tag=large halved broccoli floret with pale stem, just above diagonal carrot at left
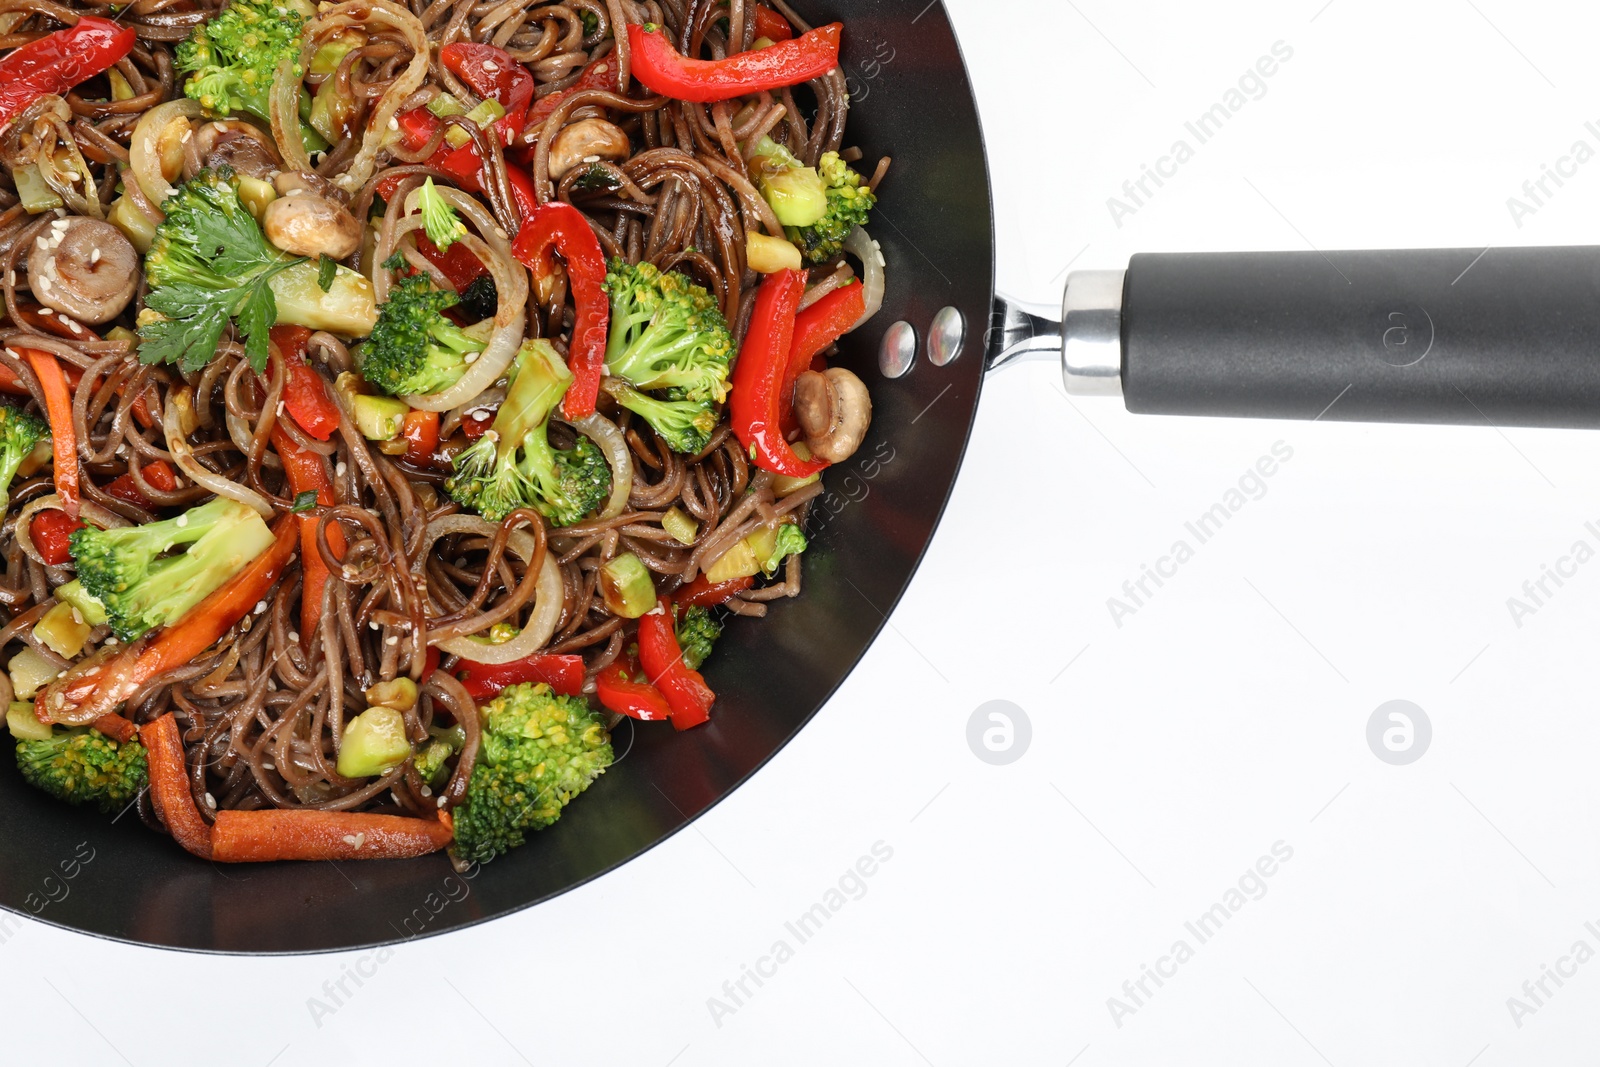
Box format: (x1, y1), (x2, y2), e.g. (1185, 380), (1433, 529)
(70, 498), (272, 641)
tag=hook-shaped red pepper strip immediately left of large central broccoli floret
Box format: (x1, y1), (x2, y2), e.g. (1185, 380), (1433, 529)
(510, 200), (611, 422)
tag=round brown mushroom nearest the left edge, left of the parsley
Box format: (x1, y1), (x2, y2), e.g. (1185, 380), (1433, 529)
(27, 218), (139, 325)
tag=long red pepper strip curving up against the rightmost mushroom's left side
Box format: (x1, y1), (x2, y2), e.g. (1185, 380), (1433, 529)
(728, 270), (827, 478)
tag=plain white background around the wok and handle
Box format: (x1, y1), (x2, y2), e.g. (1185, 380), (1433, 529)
(9, 0), (1600, 1067)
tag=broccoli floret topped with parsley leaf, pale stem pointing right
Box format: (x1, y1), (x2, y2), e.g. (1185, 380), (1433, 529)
(139, 166), (378, 373)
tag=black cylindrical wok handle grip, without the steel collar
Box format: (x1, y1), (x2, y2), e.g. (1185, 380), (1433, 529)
(1122, 248), (1600, 427)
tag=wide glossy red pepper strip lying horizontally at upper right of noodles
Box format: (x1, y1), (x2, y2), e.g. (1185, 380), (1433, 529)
(627, 22), (845, 104)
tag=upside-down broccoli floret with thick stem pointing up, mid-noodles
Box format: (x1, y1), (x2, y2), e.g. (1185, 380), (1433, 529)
(445, 339), (611, 526)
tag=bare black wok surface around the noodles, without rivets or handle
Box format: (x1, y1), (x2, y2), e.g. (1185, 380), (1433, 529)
(0, 0), (994, 953)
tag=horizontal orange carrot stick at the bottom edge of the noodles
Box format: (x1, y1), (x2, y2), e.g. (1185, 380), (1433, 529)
(211, 809), (451, 864)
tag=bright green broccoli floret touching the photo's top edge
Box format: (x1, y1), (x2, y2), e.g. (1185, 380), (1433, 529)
(174, 0), (328, 152)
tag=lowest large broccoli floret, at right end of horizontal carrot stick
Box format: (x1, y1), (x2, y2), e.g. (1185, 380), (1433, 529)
(454, 683), (613, 864)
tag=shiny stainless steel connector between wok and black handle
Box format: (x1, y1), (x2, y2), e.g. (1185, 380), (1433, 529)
(986, 270), (1126, 397)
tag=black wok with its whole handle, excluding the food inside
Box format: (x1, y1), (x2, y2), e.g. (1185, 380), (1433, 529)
(0, 0), (1574, 953)
